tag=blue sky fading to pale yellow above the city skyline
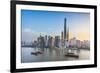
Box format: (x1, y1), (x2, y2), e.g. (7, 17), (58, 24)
(21, 10), (90, 40)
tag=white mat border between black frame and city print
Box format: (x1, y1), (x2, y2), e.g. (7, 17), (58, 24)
(16, 4), (94, 69)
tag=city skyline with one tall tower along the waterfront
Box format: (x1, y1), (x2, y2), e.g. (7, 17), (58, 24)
(21, 18), (90, 49)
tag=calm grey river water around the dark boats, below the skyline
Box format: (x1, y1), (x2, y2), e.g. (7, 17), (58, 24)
(21, 47), (90, 63)
